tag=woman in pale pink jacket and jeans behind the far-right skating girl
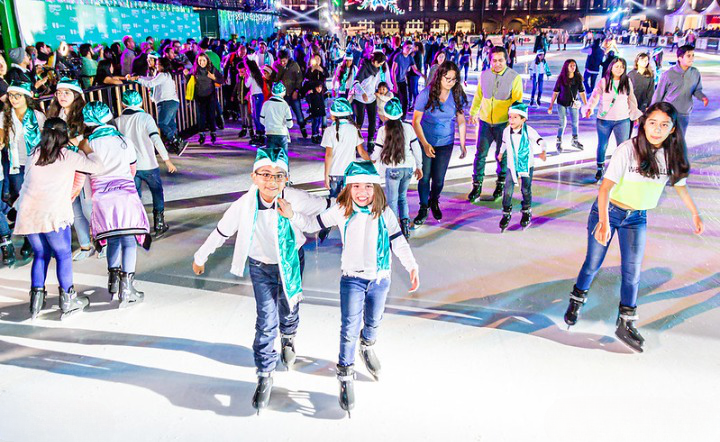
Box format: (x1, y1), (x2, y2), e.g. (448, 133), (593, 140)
(585, 58), (642, 181)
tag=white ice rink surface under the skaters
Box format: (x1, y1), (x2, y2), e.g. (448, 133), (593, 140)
(0, 46), (720, 442)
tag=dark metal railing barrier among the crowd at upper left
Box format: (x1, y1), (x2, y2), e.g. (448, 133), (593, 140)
(38, 74), (223, 136)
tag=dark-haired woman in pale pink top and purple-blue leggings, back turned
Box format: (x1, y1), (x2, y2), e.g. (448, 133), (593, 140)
(15, 118), (102, 319)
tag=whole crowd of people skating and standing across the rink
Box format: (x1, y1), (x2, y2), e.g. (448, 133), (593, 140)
(0, 26), (708, 411)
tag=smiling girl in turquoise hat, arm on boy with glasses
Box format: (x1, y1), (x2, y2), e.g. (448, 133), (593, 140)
(279, 161), (420, 413)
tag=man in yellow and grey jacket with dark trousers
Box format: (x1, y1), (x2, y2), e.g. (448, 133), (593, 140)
(468, 46), (522, 202)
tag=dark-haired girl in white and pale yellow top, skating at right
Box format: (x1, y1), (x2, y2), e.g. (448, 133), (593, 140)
(565, 102), (704, 352)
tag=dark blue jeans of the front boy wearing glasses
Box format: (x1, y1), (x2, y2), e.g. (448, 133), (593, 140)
(248, 249), (305, 373)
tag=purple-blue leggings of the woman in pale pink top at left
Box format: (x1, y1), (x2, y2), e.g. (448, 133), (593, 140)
(27, 226), (73, 291)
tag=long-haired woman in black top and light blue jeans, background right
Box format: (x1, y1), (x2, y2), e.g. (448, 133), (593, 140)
(548, 59), (587, 152)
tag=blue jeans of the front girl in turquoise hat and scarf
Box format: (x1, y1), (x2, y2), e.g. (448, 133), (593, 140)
(338, 276), (390, 367)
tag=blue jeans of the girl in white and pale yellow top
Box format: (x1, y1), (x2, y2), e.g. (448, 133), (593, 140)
(575, 200), (647, 307)
